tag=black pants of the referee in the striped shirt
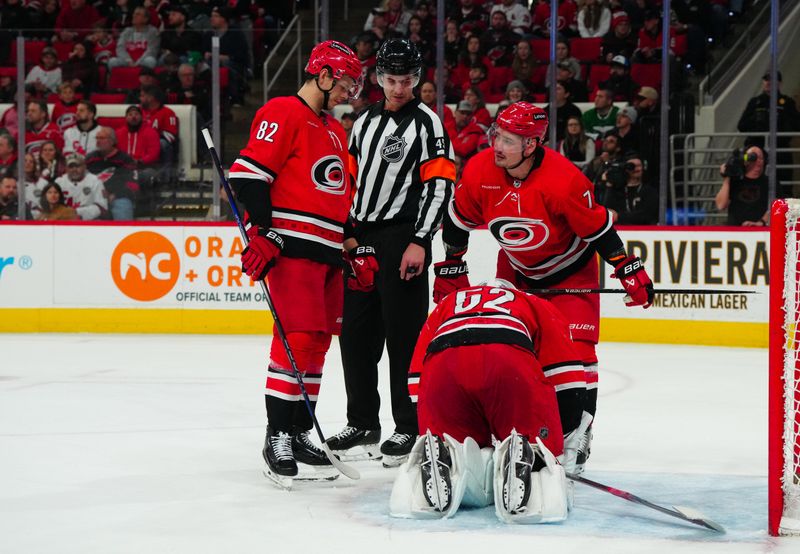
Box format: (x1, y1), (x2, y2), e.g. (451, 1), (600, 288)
(339, 223), (431, 435)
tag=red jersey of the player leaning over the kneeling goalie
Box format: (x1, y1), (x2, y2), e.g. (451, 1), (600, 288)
(449, 146), (613, 286)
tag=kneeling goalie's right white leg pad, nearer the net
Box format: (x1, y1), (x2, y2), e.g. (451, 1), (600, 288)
(494, 431), (567, 524)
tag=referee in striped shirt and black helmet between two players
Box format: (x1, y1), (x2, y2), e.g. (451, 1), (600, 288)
(328, 39), (455, 467)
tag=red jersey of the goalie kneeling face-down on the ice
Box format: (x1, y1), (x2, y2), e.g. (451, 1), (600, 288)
(408, 286), (586, 402)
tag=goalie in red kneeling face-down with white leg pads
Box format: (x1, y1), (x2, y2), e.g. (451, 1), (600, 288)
(391, 279), (586, 523)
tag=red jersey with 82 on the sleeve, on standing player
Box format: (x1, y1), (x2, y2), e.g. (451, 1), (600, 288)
(230, 96), (351, 265)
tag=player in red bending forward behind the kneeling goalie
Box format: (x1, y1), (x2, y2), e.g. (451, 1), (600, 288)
(433, 102), (654, 472)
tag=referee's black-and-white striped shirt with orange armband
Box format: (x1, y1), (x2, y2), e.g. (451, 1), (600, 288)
(349, 99), (455, 246)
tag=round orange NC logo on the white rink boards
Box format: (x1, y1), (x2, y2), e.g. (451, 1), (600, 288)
(111, 231), (181, 302)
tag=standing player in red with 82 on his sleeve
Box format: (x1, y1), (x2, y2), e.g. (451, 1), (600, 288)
(225, 40), (361, 486)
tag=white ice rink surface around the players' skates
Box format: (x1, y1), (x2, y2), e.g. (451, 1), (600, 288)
(0, 335), (800, 554)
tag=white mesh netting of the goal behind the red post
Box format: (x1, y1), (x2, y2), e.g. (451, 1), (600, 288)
(780, 200), (800, 535)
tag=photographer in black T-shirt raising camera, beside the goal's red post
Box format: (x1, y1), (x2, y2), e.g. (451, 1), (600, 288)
(714, 146), (769, 227)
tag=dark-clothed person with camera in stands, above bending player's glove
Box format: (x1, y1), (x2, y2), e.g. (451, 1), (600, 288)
(597, 152), (658, 225)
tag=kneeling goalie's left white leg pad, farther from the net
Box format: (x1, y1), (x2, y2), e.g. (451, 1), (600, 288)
(389, 431), (472, 519)
